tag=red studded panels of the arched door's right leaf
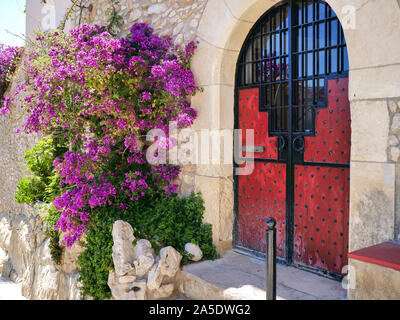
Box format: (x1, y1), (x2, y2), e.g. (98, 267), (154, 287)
(294, 78), (351, 274)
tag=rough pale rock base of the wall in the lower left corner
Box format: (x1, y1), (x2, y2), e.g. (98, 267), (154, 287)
(0, 211), (82, 300)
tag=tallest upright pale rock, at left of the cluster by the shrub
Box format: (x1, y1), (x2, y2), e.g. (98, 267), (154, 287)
(112, 220), (135, 276)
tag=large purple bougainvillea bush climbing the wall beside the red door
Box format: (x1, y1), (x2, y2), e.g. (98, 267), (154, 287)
(5, 23), (206, 247)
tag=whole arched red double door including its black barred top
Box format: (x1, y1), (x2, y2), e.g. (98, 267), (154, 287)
(234, 0), (351, 277)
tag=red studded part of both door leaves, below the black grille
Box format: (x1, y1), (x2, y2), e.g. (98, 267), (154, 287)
(235, 78), (351, 275)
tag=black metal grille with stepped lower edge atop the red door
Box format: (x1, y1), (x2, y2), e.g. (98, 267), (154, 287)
(238, 0), (349, 135)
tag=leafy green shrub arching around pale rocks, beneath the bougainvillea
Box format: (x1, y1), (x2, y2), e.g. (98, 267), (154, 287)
(78, 193), (217, 299)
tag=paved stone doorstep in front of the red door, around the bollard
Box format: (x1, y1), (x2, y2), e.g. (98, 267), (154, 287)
(184, 251), (347, 300)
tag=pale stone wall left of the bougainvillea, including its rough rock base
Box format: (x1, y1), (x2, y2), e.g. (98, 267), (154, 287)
(0, 61), (80, 299)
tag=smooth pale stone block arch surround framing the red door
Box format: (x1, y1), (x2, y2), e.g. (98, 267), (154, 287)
(191, 0), (400, 252)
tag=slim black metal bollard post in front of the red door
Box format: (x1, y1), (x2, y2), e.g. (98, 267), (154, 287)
(265, 218), (276, 300)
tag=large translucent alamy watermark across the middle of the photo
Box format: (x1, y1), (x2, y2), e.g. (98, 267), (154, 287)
(146, 122), (256, 175)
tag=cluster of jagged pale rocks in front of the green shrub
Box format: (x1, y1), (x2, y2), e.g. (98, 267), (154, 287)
(107, 220), (182, 300)
